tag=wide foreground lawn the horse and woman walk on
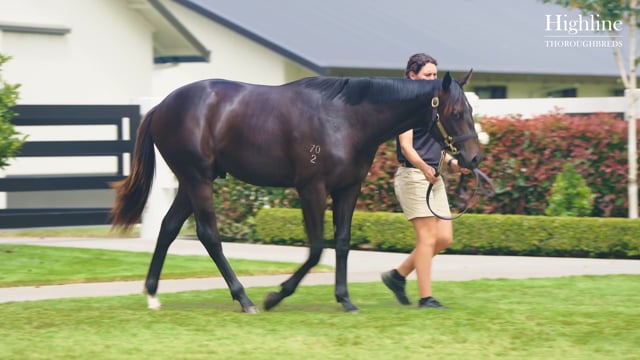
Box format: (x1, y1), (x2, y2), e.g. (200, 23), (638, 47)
(0, 275), (640, 360)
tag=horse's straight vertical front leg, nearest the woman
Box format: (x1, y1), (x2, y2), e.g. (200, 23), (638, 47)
(331, 183), (360, 313)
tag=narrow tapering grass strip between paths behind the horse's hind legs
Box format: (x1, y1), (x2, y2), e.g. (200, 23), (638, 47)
(0, 245), (332, 288)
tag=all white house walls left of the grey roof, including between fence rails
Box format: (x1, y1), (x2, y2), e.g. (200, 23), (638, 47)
(0, 0), (313, 217)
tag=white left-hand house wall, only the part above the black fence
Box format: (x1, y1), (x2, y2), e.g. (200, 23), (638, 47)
(0, 0), (153, 105)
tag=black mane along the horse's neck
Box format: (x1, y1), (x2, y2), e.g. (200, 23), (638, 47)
(298, 77), (439, 105)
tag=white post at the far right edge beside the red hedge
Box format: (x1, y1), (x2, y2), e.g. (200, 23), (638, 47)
(625, 89), (640, 219)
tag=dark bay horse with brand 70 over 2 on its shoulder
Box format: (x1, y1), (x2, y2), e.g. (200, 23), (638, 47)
(111, 72), (481, 313)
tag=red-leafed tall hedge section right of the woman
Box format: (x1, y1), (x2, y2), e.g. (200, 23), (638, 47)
(475, 114), (628, 217)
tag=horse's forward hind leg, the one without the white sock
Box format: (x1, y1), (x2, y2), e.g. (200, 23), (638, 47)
(190, 181), (257, 313)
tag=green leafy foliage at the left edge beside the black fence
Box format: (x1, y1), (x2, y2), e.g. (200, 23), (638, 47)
(0, 54), (25, 169)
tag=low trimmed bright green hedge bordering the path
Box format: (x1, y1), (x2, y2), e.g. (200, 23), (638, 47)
(256, 208), (640, 259)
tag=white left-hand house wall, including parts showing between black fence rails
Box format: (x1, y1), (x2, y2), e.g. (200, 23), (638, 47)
(0, 0), (154, 214)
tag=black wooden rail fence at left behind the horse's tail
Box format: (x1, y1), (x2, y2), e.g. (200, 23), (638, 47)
(0, 105), (140, 228)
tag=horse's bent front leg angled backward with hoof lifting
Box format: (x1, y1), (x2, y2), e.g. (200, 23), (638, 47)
(263, 184), (327, 310)
